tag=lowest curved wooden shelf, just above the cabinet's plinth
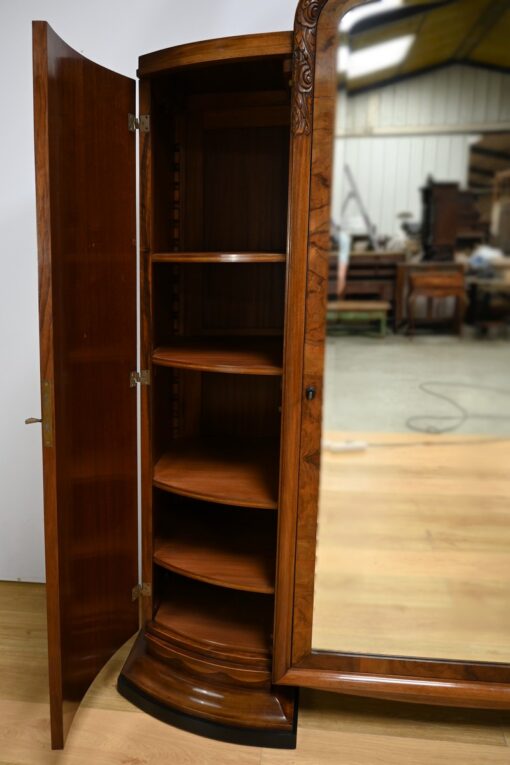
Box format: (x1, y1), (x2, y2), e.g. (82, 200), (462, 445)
(148, 575), (274, 661)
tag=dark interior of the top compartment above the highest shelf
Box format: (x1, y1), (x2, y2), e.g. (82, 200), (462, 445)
(151, 57), (290, 253)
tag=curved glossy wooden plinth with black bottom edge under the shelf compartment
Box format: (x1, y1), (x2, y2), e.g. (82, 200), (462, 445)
(117, 633), (297, 749)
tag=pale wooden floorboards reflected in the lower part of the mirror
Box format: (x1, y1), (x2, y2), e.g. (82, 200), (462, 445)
(313, 433), (510, 663)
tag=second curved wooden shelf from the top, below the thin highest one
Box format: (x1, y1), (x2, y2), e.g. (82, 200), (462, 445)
(152, 337), (282, 375)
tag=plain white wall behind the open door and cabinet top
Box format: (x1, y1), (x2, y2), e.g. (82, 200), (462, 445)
(0, 0), (297, 581)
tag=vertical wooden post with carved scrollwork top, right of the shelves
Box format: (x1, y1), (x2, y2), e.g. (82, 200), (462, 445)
(273, 0), (333, 681)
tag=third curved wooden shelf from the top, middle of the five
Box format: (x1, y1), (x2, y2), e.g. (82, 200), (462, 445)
(153, 438), (279, 510)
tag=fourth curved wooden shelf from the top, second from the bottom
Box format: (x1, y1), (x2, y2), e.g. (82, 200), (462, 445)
(154, 506), (276, 594)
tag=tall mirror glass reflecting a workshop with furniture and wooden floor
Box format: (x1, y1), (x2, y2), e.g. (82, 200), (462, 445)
(312, 0), (510, 662)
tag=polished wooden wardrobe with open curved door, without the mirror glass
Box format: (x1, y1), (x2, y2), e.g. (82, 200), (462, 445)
(34, 0), (510, 748)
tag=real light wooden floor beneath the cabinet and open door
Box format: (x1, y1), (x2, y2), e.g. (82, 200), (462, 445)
(0, 583), (510, 765)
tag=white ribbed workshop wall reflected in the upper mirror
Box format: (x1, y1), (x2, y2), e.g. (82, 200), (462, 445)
(333, 66), (510, 235)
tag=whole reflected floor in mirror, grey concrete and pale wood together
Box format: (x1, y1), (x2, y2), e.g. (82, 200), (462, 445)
(313, 336), (510, 662)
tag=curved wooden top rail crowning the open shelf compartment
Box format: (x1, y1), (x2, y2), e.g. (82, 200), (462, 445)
(138, 32), (292, 76)
